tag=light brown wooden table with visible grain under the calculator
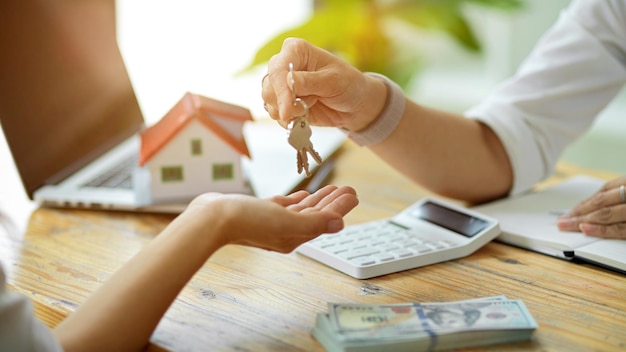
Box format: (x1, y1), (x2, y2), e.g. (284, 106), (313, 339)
(0, 143), (626, 351)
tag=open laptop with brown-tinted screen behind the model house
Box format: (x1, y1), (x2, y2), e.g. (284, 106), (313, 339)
(0, 1), (345, 213)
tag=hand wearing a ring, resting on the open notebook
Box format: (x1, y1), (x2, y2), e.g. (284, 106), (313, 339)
(557, 176), (626, 239)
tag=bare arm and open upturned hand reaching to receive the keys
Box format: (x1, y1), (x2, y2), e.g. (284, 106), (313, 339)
(55, 186), (358, 351)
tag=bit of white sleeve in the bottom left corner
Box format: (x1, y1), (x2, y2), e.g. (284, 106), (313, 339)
(0, 267), (63, 352)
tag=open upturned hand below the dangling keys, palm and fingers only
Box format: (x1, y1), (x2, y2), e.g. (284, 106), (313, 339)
(186, 185), (359, 253)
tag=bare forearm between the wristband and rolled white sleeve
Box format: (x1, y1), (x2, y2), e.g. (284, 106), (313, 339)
(370, 100), (513, 203)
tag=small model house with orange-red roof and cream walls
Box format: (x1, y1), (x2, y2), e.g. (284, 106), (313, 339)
(133, 93), (252, 204)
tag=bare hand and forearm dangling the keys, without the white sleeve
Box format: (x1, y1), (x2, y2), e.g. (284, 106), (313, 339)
(262, 38), (513, 203)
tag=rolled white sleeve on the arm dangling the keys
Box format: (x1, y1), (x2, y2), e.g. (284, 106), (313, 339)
(465, 0), (626, 194)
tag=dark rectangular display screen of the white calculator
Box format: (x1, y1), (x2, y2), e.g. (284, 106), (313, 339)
(410, 202), (489, 237)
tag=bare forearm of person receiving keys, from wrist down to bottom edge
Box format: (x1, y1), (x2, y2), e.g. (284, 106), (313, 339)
(55, 205), (223, 351)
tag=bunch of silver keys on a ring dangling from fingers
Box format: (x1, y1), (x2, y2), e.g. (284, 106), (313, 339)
(287, 64), (322, 177)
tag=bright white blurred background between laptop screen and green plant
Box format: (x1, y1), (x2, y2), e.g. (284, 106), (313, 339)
(117, 0), (311, 123)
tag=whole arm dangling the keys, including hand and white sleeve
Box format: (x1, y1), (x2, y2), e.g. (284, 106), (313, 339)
(262, 0), (626, 203)
